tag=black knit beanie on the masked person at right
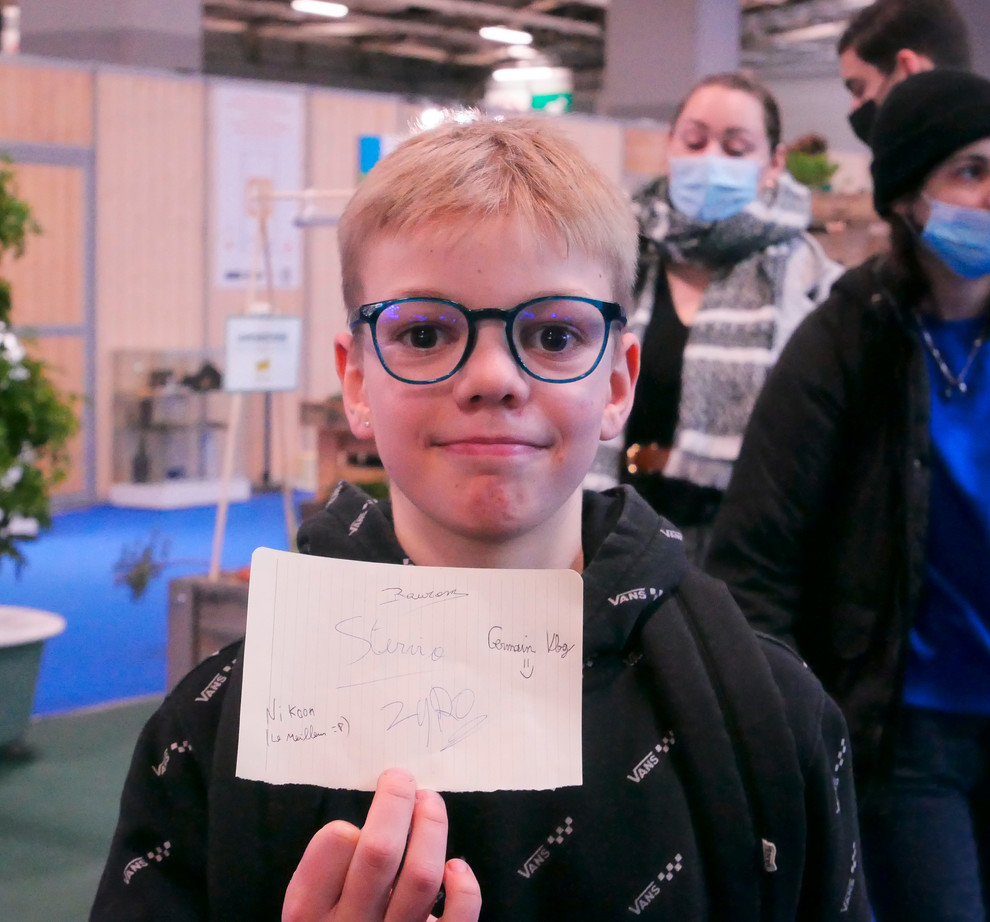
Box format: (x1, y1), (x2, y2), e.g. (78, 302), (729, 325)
(870, 69), (990, 215)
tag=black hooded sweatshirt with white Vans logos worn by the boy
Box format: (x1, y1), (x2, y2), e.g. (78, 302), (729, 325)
(92, 487), (869, 922)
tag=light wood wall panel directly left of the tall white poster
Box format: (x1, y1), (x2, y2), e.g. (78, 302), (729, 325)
(96, 71), (205, 495)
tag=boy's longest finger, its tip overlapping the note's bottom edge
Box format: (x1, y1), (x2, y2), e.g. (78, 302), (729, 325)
(334, 768), (416, 922)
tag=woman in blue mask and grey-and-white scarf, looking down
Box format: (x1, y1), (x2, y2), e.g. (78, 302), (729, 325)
(587, 73), (841, 560)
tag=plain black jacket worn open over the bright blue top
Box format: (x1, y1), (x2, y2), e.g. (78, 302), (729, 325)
(706, 257), (930, 800)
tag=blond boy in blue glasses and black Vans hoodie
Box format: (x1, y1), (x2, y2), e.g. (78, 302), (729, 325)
(93, 119), (868, 922)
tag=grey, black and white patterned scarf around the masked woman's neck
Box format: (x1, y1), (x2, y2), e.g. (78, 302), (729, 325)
(630, 173), (811, 489)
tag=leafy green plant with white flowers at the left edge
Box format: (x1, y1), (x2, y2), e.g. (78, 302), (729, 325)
(0, 157), (78, 570)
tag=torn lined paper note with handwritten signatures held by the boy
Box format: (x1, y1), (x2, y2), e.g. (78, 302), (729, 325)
(237, 548), (582, 791)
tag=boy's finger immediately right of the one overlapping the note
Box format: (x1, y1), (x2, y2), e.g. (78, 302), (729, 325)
(385, 791), (447, 922)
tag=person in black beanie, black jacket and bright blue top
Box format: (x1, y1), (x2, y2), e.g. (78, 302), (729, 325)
(707, 70), (990, 922)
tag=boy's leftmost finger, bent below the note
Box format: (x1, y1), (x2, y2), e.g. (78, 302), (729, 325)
(282, 820), (361, 922)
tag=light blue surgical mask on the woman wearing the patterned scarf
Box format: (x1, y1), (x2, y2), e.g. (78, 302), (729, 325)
(668, 154), (760, 221)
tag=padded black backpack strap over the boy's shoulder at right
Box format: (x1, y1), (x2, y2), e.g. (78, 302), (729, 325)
(642, 568), (807, 922)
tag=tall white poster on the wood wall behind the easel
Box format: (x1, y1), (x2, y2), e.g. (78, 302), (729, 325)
(212, 84), (304, 288)
